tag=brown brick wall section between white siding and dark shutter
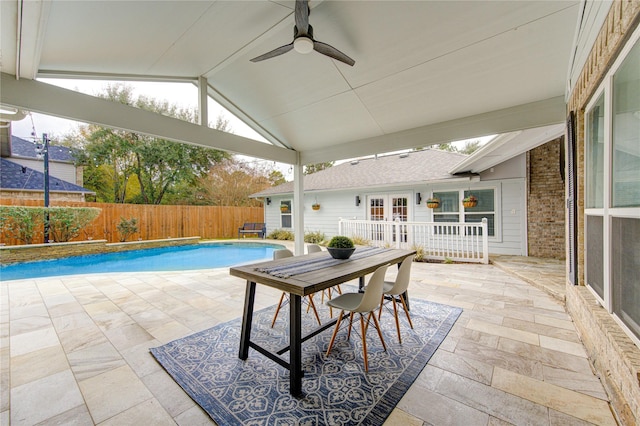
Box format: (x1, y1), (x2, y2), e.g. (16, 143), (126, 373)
(527, 137), (565, 259)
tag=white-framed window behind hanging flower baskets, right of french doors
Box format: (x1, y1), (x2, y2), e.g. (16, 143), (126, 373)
(433, 189), (496, 237)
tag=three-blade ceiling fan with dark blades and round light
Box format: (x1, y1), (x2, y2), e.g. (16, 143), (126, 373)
(251, 0), (356, 66)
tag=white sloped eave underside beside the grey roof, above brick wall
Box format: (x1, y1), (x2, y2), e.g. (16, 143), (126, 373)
(449, 123), (565, 174)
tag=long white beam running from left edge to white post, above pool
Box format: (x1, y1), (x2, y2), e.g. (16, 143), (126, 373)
(0, 73), (298, 164)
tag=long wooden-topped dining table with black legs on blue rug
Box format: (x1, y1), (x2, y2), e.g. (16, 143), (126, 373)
(229, 247), (416, 396)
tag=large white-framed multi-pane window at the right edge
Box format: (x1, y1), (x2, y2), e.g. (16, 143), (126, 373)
(584, 30), (640, 344)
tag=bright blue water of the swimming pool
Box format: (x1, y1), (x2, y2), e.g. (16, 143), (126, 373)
(0, 243), (284, 280)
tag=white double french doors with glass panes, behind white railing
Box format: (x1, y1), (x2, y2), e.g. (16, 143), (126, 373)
(367, 194), (410, 243)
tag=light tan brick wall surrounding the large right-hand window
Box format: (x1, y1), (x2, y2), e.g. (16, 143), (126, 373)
(566, 0), (640, 425)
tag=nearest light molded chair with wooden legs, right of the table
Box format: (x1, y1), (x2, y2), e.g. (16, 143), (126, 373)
(327, 265), (389, 372)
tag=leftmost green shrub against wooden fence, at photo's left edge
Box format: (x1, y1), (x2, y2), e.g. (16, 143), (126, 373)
(0, 206), (44, 244)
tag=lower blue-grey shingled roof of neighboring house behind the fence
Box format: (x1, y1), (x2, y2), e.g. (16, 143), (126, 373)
(0, 158), (94, 194)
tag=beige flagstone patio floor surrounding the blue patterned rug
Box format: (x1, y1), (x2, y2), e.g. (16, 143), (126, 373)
(0, 257), (616, 426)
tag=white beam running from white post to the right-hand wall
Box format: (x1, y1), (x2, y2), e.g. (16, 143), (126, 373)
(300, 96), (566, 164)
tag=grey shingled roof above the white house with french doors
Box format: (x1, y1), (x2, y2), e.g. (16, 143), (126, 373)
(252, 149), (467, 197)
